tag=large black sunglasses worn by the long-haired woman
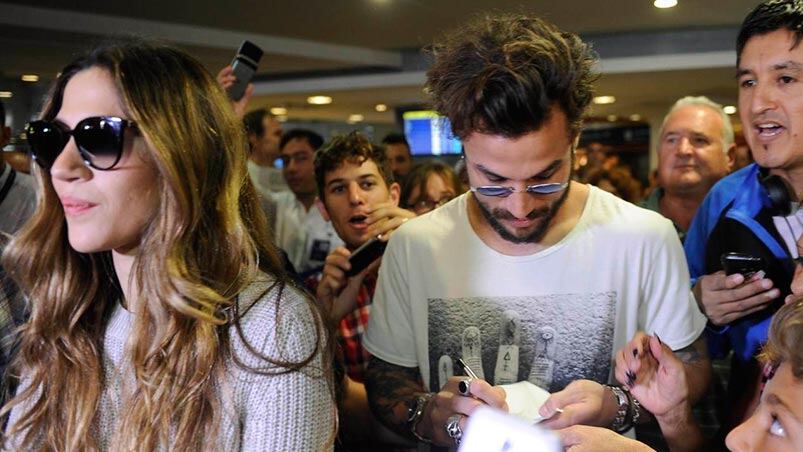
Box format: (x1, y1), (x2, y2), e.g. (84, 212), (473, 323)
(25, 116), (136, 170)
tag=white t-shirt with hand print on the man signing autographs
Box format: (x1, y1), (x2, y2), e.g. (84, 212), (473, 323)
(364, 187), (705, 392)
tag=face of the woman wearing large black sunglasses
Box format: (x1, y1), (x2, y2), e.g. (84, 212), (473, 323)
(50, 68), (160, 254)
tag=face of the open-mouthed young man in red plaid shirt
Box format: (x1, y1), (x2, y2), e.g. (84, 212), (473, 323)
(321, 160), (400, 249)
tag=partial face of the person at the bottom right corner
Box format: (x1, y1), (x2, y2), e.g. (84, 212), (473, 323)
(726, 362), (803, 452)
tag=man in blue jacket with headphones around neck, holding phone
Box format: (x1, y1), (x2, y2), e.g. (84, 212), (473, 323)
(685, 0), (803, 428)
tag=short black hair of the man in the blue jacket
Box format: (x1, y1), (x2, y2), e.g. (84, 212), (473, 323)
(736, 0), (803, 66)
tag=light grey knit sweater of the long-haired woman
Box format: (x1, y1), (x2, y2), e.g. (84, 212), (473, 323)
(5, 277), (336, 451)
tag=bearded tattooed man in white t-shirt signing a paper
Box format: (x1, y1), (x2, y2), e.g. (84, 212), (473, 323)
(364, 15), (710, 446)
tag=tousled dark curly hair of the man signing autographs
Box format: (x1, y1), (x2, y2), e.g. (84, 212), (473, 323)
(426, 14), (597, 139)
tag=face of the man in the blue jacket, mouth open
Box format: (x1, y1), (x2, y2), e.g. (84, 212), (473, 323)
(737, 29), (803, 172)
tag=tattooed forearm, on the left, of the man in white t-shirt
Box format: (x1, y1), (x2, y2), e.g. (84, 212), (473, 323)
(365, 356), (425, 438)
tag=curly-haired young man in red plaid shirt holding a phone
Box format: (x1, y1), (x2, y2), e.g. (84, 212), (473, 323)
(315, 132), (415, 383)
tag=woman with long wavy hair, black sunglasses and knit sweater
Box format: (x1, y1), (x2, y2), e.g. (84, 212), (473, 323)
(3, 42), (335, 451)
